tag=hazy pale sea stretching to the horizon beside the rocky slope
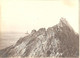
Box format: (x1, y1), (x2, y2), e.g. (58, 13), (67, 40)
(0, 32), (26, 49)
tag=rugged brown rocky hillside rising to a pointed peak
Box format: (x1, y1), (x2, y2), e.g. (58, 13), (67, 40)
(0, 18), (79, 57)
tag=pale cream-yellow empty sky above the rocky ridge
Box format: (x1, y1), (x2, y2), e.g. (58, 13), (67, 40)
(1, 0), (79, 33)
